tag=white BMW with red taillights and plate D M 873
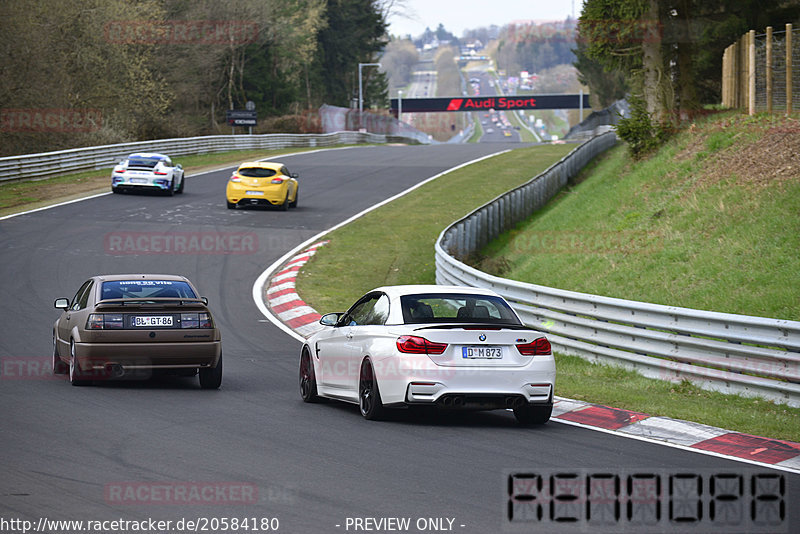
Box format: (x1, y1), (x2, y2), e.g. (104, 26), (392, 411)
(300, 285), (556, 424)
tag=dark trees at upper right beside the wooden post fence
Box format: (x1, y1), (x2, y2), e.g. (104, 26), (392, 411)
(576, 0), (800, 121)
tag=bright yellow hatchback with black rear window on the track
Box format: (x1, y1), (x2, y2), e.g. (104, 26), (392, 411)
(225, 161), (298, 211)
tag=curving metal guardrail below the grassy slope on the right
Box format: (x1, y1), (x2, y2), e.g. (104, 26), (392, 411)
(435, 133), (800, 407)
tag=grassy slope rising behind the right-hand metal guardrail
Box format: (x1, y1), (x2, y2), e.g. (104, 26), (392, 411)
(478, 113), (800, 320)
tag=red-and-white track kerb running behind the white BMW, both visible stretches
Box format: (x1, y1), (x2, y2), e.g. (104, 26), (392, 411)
(266, 245), (800, 473)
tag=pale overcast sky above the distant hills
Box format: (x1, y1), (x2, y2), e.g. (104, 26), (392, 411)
(389, 0), (583, 37)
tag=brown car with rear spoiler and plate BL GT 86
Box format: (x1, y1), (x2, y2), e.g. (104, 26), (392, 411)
(53, 274), (222, 389)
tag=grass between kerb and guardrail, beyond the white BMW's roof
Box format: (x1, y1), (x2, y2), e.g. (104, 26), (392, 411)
(298, 145), (574, 312)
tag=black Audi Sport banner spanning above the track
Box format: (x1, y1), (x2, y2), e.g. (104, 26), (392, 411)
(391, 94), (589, 113)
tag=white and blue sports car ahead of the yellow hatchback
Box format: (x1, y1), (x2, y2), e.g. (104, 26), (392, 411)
(111, 153), (183, 195)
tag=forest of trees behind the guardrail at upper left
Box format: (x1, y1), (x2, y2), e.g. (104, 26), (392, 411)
(0, 0), (390, 155)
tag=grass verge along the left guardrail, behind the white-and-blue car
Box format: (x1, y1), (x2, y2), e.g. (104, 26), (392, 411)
(0, 148), (346, 216)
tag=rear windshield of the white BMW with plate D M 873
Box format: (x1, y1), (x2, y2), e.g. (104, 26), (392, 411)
(400, 293), (521, 325)
